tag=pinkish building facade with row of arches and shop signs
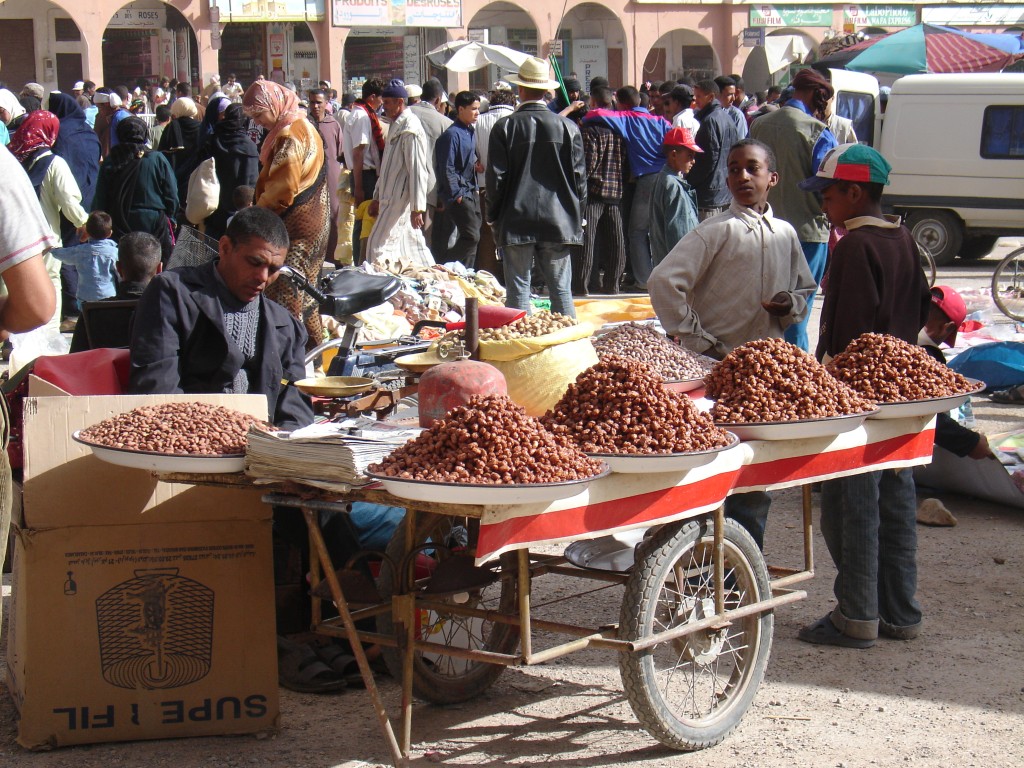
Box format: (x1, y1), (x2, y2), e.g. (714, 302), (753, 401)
(0, 0), (1024, 97)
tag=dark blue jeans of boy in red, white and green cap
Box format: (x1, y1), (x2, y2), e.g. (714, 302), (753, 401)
(821, 469), (921, 640)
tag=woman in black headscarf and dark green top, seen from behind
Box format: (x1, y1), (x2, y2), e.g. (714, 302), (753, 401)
(92, 116), (178, 262)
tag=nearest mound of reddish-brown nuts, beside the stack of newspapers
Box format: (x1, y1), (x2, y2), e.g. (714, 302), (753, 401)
(370, 395), (604, 485)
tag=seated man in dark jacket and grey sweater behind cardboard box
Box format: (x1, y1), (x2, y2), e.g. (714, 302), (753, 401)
(128, 208), (313, 429)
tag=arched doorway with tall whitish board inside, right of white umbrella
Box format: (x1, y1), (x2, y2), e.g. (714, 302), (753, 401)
(558, 3), (626, 91)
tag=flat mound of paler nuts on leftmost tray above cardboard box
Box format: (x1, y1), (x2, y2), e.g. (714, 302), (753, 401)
(80, 402), (267, 456)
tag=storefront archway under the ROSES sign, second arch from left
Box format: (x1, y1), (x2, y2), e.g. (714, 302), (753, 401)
(102, 0), (200, 88)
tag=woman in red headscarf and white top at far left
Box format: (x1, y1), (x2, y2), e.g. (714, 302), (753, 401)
(10, 110), (89, 329)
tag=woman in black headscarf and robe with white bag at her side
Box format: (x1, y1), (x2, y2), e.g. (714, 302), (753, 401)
(199, 99), (259, 239)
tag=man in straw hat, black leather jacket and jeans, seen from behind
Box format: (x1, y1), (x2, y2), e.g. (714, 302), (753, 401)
(486, 56), (587, 317)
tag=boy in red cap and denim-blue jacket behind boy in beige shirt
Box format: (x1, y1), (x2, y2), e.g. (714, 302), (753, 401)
(650, 128), (703, 266)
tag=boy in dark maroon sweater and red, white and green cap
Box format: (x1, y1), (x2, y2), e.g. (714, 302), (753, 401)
(799, 144), (932, 648)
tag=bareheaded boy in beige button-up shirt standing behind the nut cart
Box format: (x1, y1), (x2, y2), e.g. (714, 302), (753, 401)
(647, 139), (817, 547)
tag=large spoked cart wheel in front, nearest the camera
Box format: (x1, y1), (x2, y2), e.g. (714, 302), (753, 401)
(618, 519), (774, 750)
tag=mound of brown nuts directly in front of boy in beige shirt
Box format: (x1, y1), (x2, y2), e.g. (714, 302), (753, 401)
(705, 339), (874, 424)
